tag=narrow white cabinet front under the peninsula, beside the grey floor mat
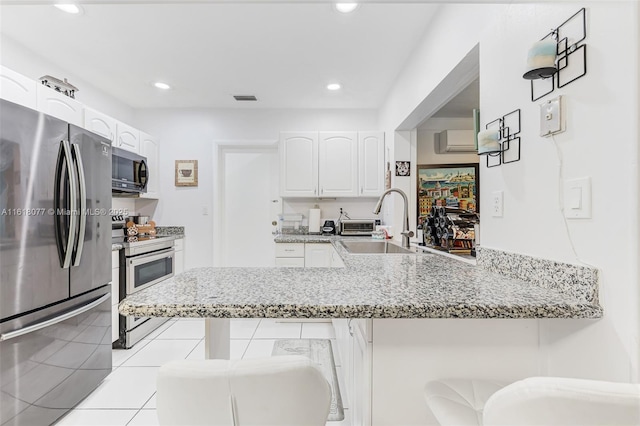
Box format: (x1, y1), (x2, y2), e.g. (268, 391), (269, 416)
(332, 319), (373, 426)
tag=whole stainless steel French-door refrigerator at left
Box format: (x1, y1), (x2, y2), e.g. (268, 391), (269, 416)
(0, 100), (111, 426)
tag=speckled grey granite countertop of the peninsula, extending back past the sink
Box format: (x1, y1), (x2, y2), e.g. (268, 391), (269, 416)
(119, 235), (602, 318)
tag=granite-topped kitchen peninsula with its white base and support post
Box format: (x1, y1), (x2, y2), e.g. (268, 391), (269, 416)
(120, 237), (602, 425)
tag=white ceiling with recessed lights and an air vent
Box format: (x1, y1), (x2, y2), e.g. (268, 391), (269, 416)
(0, 1), (439, 108)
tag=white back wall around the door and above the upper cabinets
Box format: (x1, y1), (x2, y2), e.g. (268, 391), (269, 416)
(135, 108), (378, 268)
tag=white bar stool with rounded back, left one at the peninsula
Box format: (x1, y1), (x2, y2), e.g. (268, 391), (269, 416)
(156, 355), (331, 426)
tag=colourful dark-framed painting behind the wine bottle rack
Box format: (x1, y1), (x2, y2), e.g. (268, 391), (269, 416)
(417, 163), (480, 223)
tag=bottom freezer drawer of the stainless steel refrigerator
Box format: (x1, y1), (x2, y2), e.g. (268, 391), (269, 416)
(0, 288), (112, 426)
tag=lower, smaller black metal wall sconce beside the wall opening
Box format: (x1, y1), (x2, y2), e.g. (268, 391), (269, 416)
(478, 109), (521, 167)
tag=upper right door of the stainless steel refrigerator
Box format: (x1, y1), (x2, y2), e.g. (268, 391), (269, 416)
(69, 125), (111, 296)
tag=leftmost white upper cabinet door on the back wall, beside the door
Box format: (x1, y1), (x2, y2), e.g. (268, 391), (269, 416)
(279, 132), (318, 197)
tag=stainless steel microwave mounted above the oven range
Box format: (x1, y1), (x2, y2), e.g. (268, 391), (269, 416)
(111, 148), (149, 195)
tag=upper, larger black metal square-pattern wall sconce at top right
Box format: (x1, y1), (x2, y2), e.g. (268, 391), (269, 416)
(523, 8), (587, 102)
